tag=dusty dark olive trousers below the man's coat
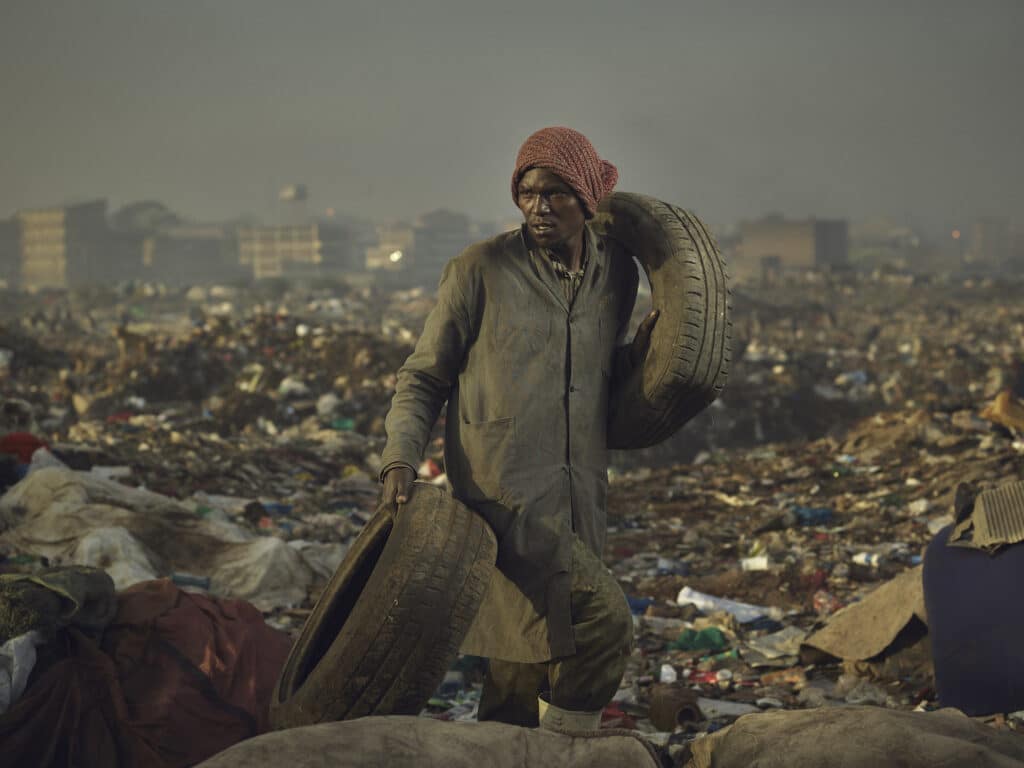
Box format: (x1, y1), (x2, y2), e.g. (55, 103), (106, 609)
(478, 538), (633, 727)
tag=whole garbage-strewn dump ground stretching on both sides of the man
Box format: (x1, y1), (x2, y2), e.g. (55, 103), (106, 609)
(0, 275), (1024, 765)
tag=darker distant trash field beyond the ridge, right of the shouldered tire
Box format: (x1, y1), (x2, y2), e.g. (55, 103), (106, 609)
(614, 275), (1024, 468)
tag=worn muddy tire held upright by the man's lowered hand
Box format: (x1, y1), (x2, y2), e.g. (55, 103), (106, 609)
(270, 482), (497, 728)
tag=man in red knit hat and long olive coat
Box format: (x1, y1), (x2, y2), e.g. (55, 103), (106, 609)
(381, 127), (656, 730)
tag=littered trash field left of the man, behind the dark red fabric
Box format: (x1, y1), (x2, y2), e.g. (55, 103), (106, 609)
(0, 289), (426, 643)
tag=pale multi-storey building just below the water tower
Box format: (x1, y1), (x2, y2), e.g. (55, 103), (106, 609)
(238, 222), (364, 280)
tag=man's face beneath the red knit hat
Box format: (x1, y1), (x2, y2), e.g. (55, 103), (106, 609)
(518, 168), (587, 250)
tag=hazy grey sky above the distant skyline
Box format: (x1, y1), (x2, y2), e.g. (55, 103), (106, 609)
(0, 0), (1024, 236)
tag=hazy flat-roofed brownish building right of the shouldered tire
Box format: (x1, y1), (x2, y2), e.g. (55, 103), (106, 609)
(730, 216), (849, 281)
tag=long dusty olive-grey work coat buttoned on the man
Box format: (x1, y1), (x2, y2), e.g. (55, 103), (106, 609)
(382, 225), (638, 662)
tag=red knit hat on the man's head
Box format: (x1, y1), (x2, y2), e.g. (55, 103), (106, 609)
(512, 127), (618, 218)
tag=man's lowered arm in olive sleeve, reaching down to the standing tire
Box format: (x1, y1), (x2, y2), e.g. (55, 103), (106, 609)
(381, 261), (472, 504)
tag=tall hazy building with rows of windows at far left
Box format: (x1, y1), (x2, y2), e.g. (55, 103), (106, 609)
(15, 200), (141, 289)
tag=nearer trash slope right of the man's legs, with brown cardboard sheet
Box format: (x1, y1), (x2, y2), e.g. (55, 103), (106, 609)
(608, 410), (1024, 745)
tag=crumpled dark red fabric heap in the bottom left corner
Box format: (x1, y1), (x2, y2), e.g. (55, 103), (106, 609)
(0, 580), (291, 768)
